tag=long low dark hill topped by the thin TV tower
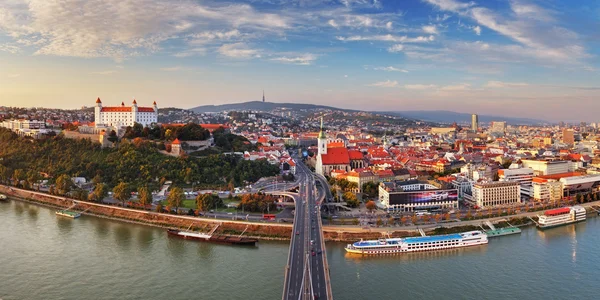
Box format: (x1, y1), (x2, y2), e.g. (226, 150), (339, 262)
(190, 101), (355, 113)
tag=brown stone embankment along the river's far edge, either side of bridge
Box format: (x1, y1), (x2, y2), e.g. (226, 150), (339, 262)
(0, 185), (600, 242)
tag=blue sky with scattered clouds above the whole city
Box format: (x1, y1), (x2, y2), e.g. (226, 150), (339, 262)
(0, 0), (600, 122)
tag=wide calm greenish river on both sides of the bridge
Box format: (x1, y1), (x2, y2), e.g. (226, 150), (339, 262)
(0, 200), (600, 300)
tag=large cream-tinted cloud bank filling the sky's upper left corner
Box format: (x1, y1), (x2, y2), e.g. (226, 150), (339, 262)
(0, 0), (289, 60)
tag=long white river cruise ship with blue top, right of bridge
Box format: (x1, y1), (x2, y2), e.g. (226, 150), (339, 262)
(345, 230), (488, 255)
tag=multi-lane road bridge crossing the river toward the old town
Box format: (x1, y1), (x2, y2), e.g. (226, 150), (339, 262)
(282, 162), (333, 300)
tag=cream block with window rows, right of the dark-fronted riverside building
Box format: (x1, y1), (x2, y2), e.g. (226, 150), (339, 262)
(472, 181), (521, 207)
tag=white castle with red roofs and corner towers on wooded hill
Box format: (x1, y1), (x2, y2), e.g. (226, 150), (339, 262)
(94, 98), (158, 128)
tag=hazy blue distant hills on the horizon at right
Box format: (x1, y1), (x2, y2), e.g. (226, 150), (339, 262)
(388, 110), (548, 125)
